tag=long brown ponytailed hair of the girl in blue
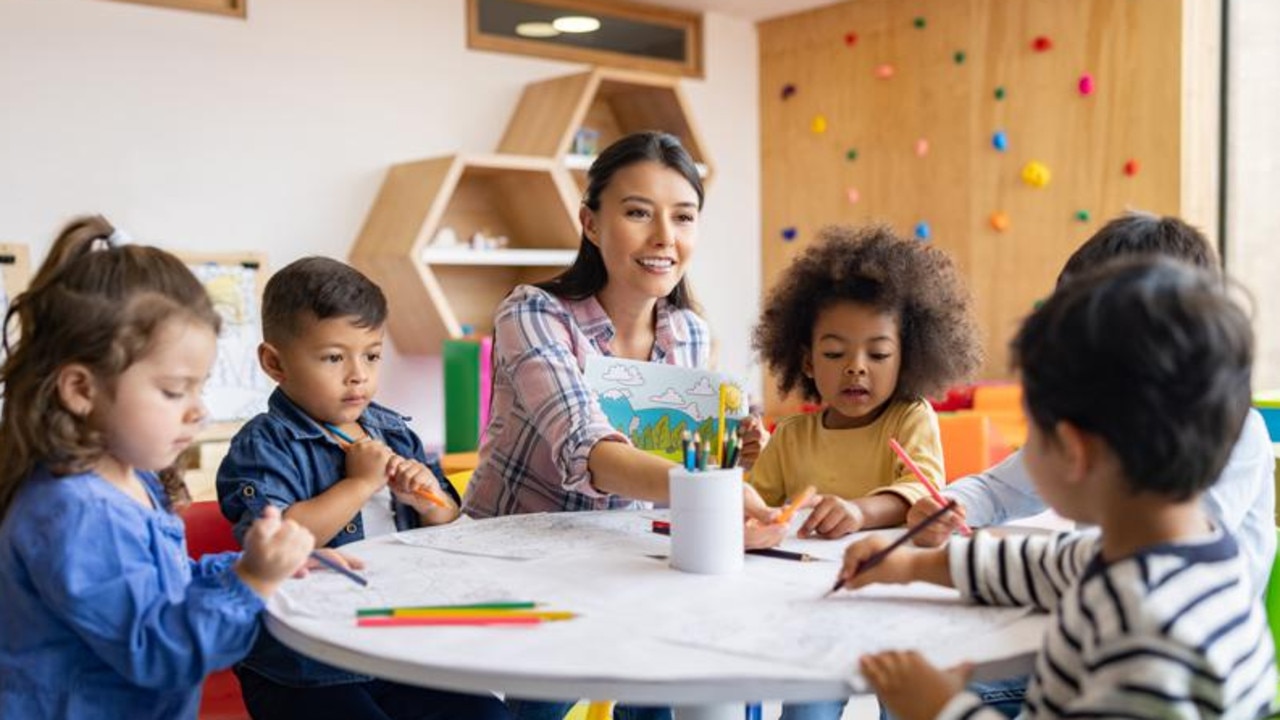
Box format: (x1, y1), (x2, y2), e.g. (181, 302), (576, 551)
(0, 217), (221, 519)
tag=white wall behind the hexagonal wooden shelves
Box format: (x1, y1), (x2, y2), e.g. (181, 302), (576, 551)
(0, 0), (760, 445)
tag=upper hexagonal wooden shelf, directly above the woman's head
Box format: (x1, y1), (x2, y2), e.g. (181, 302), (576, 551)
(498, 68), (710, 184)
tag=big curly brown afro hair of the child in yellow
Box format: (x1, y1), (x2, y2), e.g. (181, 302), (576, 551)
(753, 225), (982, 401)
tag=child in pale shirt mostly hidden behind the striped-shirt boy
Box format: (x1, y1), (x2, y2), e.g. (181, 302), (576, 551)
(906, 213), (1276, 596)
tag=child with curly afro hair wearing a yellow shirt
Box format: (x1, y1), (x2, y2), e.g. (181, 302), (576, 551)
(751, 225), (982, 538)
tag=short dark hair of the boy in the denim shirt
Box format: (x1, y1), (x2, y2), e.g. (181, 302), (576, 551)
(262, 256), (387, 345)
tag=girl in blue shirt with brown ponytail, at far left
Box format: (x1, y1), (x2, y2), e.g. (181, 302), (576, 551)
(0, 218), (314, 719)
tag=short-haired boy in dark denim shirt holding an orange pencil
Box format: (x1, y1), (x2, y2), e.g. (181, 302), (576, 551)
(218, 258), (507, 720)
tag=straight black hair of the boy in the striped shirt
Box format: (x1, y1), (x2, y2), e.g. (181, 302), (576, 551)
(1012, 256), (1253, 501)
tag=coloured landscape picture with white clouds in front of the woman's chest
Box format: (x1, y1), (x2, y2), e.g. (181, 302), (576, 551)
(584, 355), (749, 462)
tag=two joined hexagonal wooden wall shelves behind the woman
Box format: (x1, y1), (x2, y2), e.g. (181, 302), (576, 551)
(349, 68), (712, 355)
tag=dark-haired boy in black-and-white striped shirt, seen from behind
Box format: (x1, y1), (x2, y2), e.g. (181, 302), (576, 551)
(841, 259), (1276, 720)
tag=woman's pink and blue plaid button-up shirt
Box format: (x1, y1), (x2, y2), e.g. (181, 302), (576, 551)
(463, 286), (710, 518)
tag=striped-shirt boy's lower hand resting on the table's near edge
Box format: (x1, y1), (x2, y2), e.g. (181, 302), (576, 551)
(859, 651), (973, 720)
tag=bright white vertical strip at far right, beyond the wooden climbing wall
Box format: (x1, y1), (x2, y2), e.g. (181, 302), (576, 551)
(1225, 0), (1280, 389)
